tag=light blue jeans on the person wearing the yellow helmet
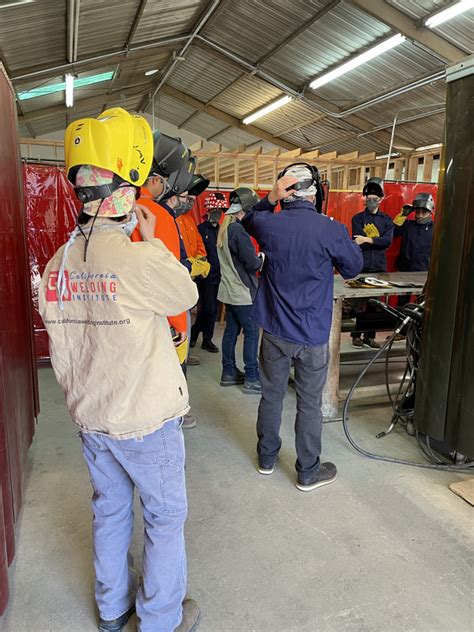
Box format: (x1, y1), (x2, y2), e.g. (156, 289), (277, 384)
(81, 419), (187, 632)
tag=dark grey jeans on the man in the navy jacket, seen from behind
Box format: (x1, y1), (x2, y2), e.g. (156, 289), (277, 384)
(257, 332), (329, 482)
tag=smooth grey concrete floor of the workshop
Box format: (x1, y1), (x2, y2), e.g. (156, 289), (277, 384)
(0, 331), (474, 632)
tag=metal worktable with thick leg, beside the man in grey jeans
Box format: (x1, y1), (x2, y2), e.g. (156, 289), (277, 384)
(322, 272), (428, 419)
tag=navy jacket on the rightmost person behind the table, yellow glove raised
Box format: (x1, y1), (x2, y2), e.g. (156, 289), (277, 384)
(394, 220), (433, 272)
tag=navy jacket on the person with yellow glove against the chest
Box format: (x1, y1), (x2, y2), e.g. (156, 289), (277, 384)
(352, 209), (393, 272)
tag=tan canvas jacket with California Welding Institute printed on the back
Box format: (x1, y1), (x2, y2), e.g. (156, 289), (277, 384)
(39, 218), (198, 439)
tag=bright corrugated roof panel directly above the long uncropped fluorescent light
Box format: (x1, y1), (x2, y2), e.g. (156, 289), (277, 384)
(263, 4), (390, 85)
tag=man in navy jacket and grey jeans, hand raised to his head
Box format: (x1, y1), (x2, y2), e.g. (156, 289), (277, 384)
(242, 163), (363, 491)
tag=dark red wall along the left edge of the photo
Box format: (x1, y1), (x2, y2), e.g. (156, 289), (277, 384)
(0, 64), (38, 615)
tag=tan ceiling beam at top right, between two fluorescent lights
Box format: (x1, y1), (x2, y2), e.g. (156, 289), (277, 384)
(351, 0), (466, 61)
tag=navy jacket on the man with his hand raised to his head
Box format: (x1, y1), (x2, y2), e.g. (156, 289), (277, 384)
(242, 198), (363, 346)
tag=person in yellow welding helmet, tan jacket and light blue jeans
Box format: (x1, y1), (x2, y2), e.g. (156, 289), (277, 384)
(39, 108), (199, 630)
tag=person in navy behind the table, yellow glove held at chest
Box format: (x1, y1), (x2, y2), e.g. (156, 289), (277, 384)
(351, 178), (393, 349)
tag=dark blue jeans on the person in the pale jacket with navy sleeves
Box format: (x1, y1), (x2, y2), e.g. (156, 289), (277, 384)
(222, 303), (259, 382)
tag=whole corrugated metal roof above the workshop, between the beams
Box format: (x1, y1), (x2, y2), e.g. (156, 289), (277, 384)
(0, 0), (468, 151)
